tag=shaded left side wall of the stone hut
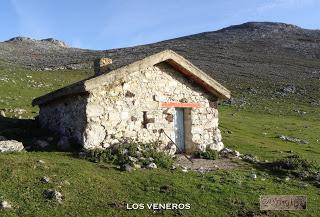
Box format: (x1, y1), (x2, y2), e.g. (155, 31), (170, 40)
(39, 96), (88, 145)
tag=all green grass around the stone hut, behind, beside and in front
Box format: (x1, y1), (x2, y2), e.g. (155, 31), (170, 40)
(0, 67), (320, 216)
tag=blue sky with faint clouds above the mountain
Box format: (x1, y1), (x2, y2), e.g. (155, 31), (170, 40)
(0, 0), (320, 50)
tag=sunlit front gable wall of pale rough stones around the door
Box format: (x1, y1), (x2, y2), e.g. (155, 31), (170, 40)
(84, 63), (223, 152)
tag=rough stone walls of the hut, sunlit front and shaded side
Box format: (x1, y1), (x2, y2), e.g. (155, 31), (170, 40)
(34, 49), (230, 154)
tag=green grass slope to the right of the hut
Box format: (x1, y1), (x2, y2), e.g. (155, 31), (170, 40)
(220, 107), (320, 165)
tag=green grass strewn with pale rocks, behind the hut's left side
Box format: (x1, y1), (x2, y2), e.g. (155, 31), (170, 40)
(0, 65), (92, 118)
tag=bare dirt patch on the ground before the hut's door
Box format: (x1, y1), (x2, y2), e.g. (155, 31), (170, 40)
(175, 155), (241, 171)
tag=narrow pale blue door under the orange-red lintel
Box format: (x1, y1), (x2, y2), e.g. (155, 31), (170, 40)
(175, 108), (185, 152)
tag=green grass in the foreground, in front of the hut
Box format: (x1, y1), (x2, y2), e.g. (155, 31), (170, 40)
(0, 152), (320, 216)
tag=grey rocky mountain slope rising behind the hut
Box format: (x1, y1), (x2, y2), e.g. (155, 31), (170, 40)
(0, 22), (320, 91)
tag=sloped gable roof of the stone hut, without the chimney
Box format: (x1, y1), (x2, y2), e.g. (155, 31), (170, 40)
(32, 50), (230, 106)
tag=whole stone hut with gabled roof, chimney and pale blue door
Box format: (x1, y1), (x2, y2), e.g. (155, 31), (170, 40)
(32, 50), (230, 153)
